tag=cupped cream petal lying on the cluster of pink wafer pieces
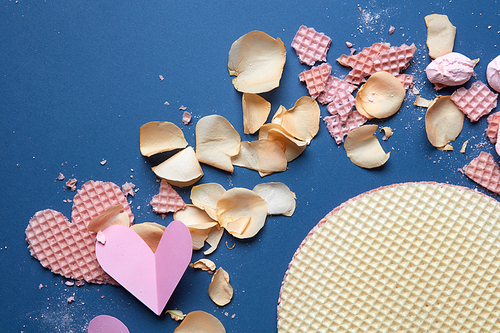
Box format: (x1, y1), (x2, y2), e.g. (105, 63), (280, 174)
(356, 72), (406, 118)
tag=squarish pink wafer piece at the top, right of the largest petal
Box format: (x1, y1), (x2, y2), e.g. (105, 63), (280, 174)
(292, 25), (332, 66)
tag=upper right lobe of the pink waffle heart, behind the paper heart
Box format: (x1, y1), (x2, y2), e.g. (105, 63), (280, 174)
(71, 180), (134, 226)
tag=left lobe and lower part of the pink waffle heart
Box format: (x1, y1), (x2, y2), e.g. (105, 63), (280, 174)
(26, 209), (116, 284)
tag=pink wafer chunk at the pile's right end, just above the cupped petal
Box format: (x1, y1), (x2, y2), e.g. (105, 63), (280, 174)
(371, 44), (417, 75)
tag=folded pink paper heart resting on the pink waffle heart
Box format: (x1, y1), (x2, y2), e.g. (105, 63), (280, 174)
(96, 221), (193, 315)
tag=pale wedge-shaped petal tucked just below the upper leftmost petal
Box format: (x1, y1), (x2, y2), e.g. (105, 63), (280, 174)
(152, 147), (203, 187)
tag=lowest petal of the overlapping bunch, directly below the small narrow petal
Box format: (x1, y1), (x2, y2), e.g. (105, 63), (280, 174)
(232, 140), (287, 176)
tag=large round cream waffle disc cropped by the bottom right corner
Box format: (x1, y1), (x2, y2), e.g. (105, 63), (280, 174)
(278, 183), (500, 333)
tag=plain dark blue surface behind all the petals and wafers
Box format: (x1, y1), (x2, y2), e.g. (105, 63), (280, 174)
(0, 0), (500, 332)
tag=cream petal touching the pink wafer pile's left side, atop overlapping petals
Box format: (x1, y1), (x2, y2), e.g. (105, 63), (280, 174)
(272, 96), (318, 142)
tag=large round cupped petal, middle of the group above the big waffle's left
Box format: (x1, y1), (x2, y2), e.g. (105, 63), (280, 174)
(217, 187), (267, 238)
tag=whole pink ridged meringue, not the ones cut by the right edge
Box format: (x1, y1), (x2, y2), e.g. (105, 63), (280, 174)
(425, 52), (474, 90)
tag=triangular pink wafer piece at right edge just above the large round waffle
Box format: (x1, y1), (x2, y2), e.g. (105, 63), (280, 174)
(463, 151), (500, 194)
